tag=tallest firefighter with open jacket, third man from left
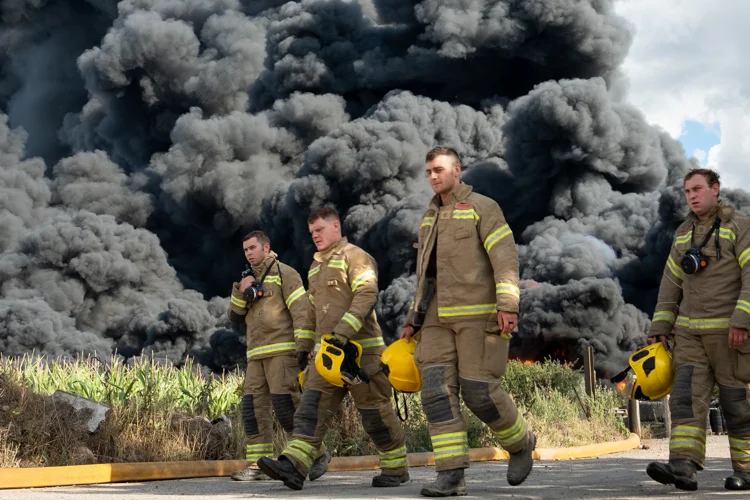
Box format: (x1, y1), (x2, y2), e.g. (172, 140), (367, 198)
(401, 146), (536, 496)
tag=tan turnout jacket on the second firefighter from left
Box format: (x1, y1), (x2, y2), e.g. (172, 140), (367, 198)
(296, 237), (385, 354)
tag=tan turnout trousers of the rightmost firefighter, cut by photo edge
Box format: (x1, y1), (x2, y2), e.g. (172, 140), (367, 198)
(669, 327), (750, 472)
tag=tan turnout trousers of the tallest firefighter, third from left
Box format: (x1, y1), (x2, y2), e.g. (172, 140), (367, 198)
(414, 294), (528, 471)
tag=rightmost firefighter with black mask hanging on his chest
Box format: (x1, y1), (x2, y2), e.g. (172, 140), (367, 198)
(646, 169), (750, 490)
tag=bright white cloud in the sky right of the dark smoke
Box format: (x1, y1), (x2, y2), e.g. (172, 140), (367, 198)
(615, 0), (750, 190)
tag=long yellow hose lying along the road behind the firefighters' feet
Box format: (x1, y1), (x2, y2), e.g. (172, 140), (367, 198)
(0, 434), (641, 489)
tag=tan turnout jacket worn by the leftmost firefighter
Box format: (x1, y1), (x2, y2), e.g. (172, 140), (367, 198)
(227, 252), (315, 360)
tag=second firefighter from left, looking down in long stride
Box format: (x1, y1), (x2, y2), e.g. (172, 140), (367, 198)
(258, 208), (409, 490)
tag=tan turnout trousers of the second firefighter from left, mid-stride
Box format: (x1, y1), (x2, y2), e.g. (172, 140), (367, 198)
(281, 348), (407, 476)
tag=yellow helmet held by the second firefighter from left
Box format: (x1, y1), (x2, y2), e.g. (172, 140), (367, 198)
(315, 334), (370, 387)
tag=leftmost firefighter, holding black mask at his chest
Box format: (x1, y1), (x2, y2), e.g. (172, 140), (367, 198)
(227, 231), (331, 481)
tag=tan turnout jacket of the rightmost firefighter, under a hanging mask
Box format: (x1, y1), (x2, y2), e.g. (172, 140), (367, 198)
(649, 201), (750, 336)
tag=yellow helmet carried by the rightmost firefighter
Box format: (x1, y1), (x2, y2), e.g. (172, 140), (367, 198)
(629, 342), (674, 401)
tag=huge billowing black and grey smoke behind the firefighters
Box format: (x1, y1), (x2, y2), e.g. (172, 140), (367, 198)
(0, 0), (750, 373)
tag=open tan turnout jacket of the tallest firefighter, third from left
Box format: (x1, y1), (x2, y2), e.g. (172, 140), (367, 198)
(406, 182), (520, 326)
